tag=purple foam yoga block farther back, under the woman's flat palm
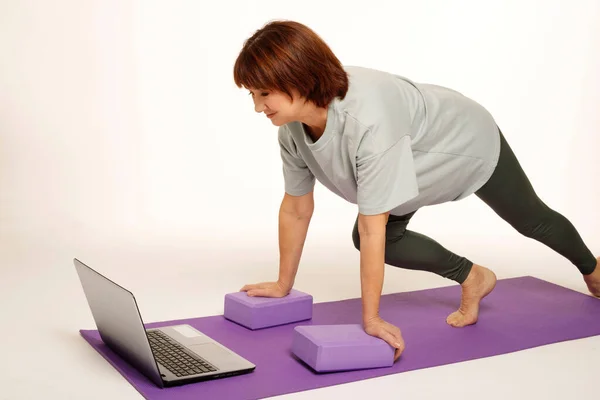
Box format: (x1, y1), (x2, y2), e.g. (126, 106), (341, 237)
(224, 289), (313, 329)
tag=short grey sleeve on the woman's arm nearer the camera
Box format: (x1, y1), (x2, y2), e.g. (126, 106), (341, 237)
(356, 134), (419, 215)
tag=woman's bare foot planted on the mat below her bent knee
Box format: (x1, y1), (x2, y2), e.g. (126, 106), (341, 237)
(446, 264), (496, 328)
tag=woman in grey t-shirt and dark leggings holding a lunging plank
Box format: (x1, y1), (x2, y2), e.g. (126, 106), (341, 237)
(234, 21), (600, 360)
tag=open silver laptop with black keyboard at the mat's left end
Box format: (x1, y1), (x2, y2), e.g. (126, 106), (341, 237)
(73, 258), (256, 388)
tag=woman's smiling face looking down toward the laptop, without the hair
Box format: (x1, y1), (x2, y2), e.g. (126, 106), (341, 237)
(249, 89), (304, 126)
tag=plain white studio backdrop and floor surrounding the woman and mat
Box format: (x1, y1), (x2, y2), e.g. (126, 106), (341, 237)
(0, 0), (600, 399)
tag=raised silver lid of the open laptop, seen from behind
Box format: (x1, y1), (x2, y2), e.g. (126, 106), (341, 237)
(73, 258), (163, 387)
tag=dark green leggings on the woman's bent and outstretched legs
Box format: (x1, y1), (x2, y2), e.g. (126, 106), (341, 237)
(352, 132), (596, 283)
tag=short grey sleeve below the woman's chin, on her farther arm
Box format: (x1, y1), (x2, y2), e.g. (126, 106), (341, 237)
(278, 126), (315, 196)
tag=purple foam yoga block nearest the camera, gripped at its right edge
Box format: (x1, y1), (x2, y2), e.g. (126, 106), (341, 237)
(292, 324), (395, 372)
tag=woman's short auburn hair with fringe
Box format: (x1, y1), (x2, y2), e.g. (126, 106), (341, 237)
(233, 20), (348, 107)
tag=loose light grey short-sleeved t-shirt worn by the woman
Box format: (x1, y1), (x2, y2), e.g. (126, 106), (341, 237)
(279, 66), (500, 215)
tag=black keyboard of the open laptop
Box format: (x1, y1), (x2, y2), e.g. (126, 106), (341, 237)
(147, 331), (217, 377)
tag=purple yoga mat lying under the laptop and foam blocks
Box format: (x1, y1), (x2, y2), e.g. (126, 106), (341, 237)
(81, 277), (600, 400)
